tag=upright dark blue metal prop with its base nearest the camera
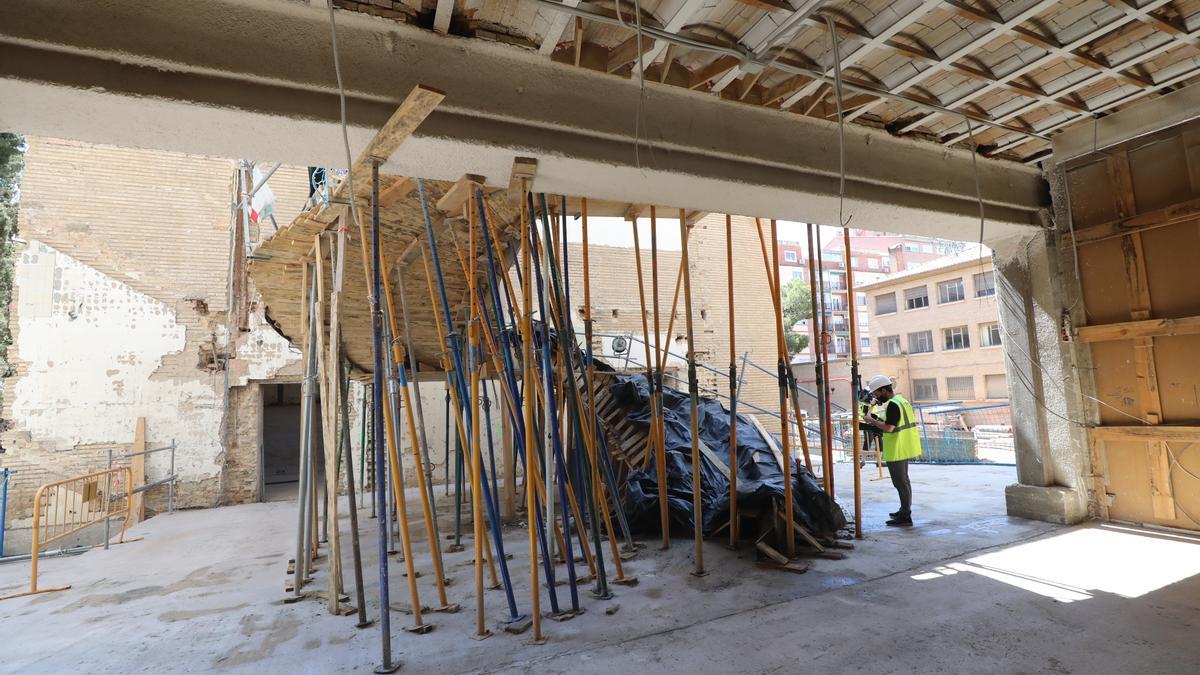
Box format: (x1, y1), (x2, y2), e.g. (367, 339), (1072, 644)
(371, 162), (400, 674)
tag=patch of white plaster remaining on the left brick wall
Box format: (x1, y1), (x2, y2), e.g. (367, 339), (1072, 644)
(12, 241), (224, 480)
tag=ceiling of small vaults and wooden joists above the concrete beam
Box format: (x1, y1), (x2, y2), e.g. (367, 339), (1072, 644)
(335, 0), (1200, 162)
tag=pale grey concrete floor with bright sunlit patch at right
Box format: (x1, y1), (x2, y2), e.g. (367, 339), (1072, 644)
(0, 465), (1200, 673)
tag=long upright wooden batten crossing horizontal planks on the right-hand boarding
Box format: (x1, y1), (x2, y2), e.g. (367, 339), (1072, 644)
(1108, 153), (1176, 520)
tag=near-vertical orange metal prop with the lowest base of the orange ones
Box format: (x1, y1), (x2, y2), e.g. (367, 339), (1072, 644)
(518, 178), (557, 645)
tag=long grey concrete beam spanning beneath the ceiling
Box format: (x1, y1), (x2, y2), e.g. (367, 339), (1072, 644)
(0, 0), (1049, 239)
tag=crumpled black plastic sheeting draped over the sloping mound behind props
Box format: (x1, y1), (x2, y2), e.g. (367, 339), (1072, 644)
(608, 375), (846, 537)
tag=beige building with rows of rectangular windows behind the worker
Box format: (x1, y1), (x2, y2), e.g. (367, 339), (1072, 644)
(857, 246), (1008, 402)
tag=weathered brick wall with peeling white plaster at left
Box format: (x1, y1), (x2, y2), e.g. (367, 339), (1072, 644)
(0, 138), (307, 526)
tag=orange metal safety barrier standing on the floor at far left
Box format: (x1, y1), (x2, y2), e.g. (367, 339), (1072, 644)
(0, 466), (133, 601)
